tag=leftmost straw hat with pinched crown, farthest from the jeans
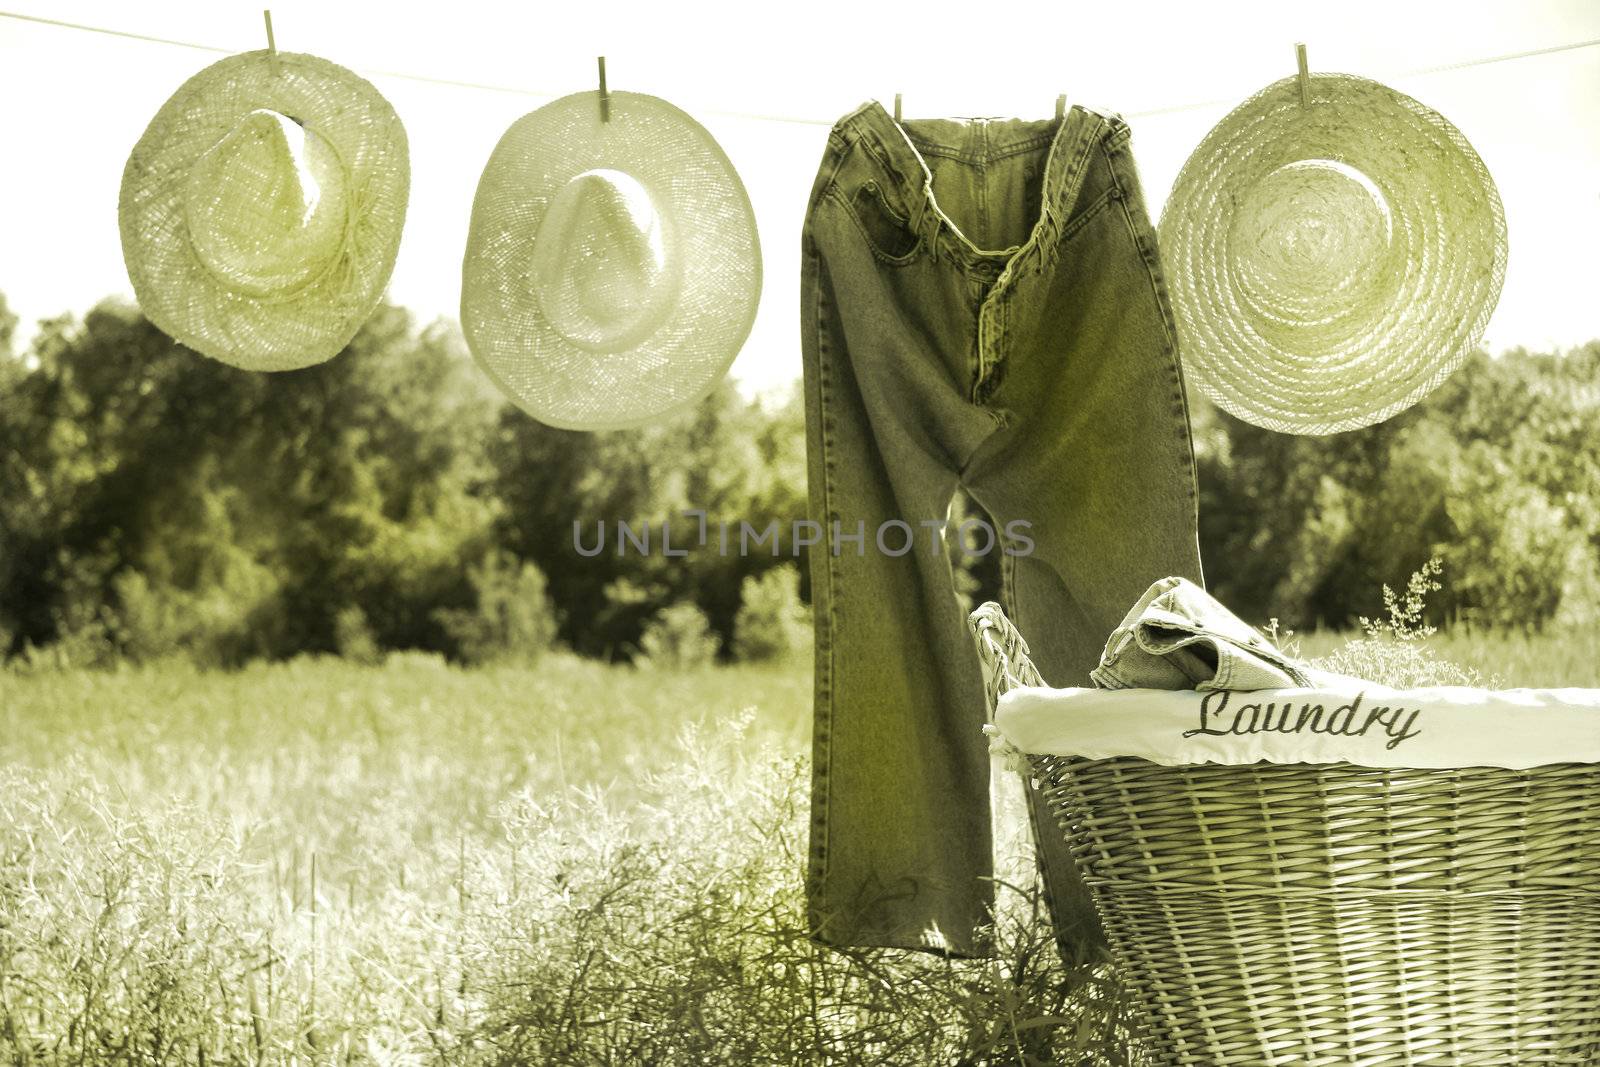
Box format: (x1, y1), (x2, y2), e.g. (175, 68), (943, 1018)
(118, 51), (411, 371)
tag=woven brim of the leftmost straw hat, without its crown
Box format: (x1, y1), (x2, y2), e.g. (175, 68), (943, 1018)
(118, 51), (411, 371)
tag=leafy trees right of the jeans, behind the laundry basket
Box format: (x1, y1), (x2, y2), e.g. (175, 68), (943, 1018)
(1197, 342), (1600, 625)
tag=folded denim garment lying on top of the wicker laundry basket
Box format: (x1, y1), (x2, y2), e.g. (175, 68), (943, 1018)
(1090, 577), (1350, 691)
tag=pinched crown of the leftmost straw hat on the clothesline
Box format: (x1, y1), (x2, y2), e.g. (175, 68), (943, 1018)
(184, 109), (350, 298)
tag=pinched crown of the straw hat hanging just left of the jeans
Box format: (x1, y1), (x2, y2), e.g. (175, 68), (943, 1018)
(530, 168), (680, 352)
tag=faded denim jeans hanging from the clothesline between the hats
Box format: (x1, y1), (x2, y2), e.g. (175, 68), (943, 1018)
(800, 104), (1200, 955)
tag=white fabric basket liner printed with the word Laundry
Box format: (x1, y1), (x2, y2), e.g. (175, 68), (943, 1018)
(994, 681), (1600, 769)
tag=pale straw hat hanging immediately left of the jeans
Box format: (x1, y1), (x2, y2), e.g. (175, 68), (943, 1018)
(461, 91), (762, 430)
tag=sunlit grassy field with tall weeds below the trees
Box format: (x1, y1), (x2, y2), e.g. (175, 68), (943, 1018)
(0, 632), (1600, 1065)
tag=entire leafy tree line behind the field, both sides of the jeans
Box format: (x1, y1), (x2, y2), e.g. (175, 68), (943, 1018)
(0, 292), (1600, 665)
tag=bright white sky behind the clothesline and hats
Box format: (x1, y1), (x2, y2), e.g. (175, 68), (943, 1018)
(0, 0), (1600, 398)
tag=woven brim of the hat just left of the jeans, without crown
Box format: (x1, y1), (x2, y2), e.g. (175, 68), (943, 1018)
(461, 91), (762, 430)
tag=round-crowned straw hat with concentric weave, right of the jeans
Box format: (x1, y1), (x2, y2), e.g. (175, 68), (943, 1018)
(1160, 74), (1506, 434)
